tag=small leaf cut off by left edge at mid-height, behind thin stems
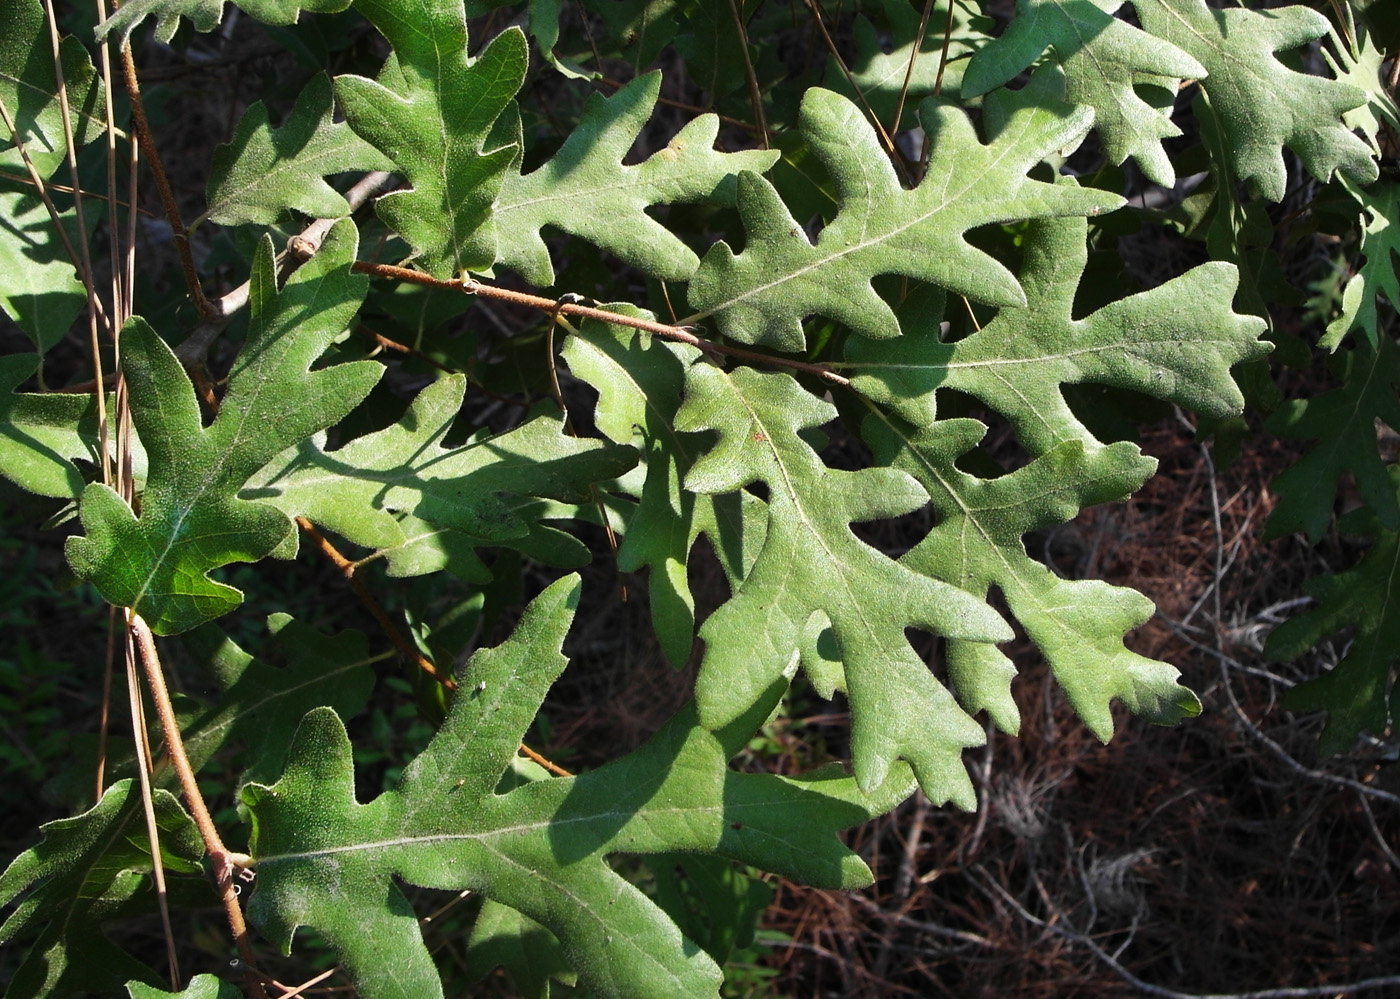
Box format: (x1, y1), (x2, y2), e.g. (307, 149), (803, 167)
(0, 354), (98, 500)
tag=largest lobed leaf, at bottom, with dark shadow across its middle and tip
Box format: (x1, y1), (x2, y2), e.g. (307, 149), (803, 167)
(244, 576), (911, 999)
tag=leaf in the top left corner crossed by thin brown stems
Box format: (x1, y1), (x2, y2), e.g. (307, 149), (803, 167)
(0, 0), (106, 165)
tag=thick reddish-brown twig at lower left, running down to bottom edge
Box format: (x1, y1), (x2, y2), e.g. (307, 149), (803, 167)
(127, 611), (267, 999)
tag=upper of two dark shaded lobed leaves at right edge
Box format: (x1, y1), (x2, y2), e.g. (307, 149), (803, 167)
(1264, 337), (1400, 544)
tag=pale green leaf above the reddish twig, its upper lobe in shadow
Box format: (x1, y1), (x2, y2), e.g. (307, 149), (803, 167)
(494, 73), (778, 287)
